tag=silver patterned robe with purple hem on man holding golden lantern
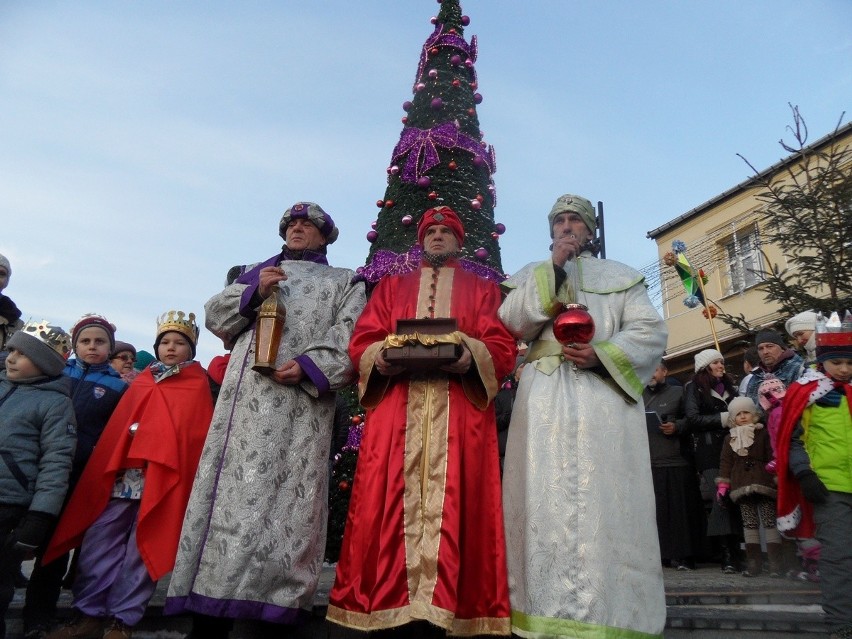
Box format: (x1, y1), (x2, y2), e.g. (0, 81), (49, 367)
(166, 259), (365, 623)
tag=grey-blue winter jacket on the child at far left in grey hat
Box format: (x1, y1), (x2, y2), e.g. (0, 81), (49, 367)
(0, 371), (77, 515)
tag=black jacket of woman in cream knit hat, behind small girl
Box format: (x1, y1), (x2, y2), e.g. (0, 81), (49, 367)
(683, 382), (733, 472)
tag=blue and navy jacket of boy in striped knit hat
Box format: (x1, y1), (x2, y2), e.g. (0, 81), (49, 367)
(63, 359), (127, 483)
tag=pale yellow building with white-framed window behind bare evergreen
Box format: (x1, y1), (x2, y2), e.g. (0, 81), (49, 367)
(648, 123), (852, 379)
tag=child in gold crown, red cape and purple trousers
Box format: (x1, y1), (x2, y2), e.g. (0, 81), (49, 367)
(44, 311), (213, 639)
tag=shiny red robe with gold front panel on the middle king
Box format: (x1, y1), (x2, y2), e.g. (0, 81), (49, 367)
(327, 262), (517, 635)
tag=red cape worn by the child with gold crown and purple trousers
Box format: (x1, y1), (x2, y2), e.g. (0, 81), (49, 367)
(44, 362), (213, 581)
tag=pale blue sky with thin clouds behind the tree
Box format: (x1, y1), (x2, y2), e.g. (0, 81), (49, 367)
(0, 0), (852, 364)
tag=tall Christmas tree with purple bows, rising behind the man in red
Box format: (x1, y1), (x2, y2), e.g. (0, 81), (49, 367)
(359, 0), (505, 283)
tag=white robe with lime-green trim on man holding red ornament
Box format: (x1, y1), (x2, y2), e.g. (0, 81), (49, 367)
(500, 253), (667, 639)
